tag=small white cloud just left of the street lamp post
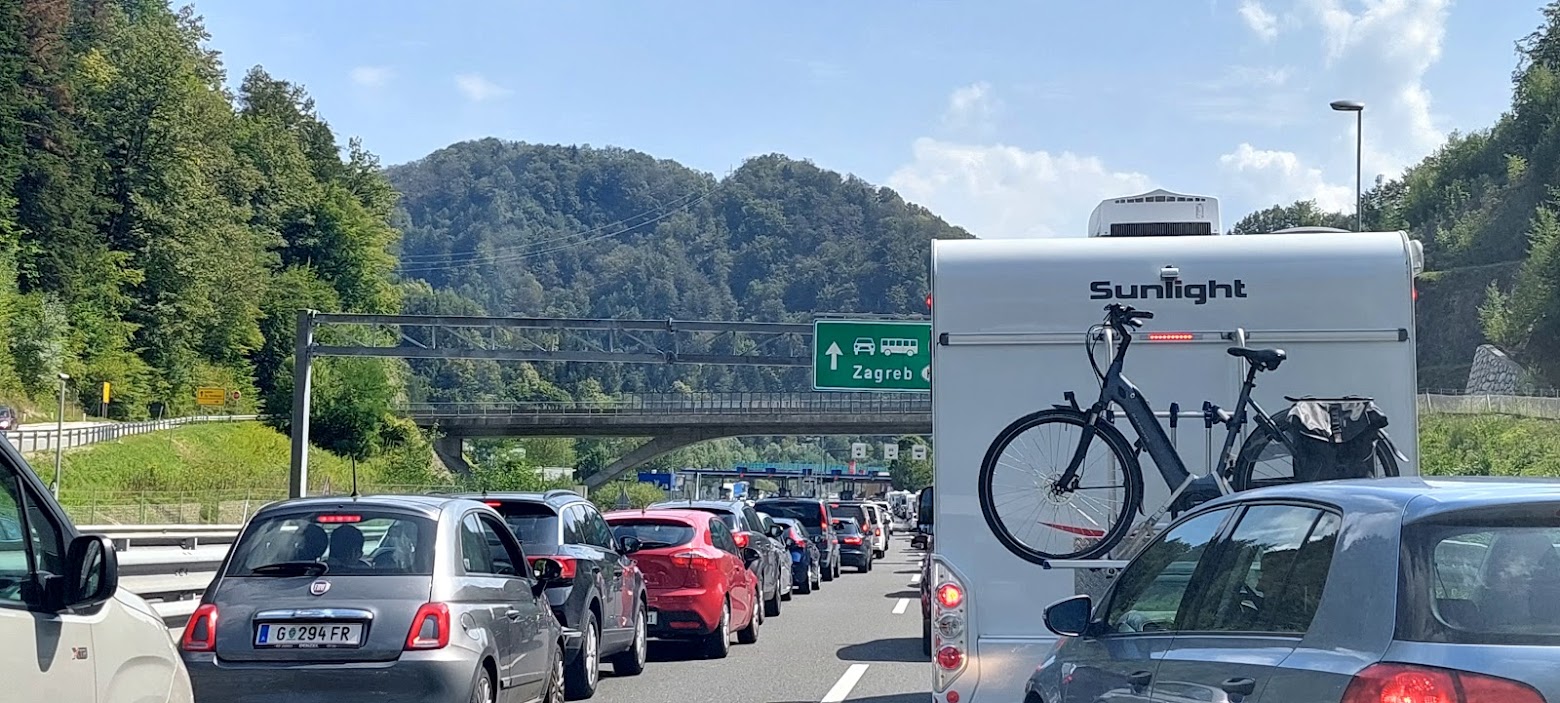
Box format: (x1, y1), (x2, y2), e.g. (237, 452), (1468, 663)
(1218, 143), (1354, 212)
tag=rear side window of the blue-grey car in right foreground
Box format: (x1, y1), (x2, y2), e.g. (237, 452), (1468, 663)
(1182, 505), (1338, 633)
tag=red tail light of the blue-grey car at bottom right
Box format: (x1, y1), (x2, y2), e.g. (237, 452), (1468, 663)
(1343, 664), (1544, 703)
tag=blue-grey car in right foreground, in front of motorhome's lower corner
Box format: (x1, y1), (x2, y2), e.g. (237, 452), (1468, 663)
(1023, 477), (1560, 703)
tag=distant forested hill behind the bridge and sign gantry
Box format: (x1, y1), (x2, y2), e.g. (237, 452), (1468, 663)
(387, 139), (969, 401)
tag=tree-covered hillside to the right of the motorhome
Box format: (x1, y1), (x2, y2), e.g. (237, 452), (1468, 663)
(1236, 2), (1560, 388)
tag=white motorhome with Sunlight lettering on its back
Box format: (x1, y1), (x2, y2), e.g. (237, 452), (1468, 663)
(931, 232), (1423, 703)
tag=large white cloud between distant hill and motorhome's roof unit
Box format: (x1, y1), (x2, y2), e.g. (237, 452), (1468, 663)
(888, 137), (1154, 238)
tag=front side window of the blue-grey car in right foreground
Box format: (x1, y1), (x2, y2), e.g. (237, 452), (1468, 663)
(1104, 508), (1232, 633)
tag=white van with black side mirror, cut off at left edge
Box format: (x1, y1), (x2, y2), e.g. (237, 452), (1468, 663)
(0, 441), (193, 703)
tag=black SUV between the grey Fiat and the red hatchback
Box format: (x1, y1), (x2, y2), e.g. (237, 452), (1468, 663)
(455, 488), (649, 700)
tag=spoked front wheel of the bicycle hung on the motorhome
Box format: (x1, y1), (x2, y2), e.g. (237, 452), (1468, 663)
(980, 408), (1143, 564)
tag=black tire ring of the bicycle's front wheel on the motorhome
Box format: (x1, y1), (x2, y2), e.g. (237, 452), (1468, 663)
(978, 408), (1143, 564)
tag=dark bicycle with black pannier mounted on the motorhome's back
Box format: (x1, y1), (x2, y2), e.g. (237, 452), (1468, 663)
(980, 304), (1398, 567)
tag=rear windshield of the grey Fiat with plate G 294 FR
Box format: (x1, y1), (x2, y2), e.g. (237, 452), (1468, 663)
(228, 510), (437, 577)
